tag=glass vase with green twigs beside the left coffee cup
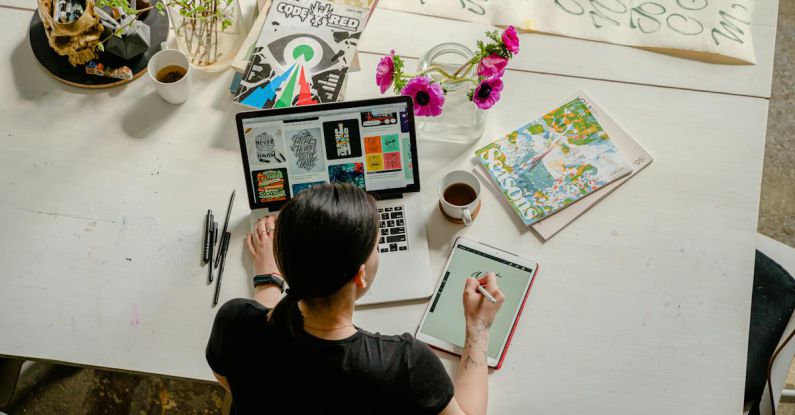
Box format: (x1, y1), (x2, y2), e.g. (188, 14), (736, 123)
(168, 0), (244, 72)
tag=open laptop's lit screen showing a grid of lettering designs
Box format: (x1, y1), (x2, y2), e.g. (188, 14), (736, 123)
(237, 97), (419, 210)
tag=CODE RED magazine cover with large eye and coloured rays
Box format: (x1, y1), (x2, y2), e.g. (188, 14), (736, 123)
(234, 0), (368, 108)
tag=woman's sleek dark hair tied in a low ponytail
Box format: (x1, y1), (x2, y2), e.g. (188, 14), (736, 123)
(270, 184), (379, 335)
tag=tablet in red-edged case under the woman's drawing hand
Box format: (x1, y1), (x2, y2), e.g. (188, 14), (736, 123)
(416, 238), (538, 369)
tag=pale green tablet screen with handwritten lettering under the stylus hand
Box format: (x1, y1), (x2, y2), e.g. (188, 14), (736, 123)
(419, 244), (535, 359)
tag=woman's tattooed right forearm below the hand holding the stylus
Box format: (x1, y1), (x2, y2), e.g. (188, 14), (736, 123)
(455, 321), (489, 415)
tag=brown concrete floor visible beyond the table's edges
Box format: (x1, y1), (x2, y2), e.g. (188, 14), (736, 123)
(5, 0), (795, 415)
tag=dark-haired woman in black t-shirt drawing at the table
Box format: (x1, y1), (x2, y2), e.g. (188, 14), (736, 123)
(207, 184), (504, 414)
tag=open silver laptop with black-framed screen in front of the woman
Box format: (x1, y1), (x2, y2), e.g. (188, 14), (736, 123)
(236, 96), (433, 305)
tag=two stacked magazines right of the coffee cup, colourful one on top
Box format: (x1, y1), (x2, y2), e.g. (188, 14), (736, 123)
(475, 93), (653, 240)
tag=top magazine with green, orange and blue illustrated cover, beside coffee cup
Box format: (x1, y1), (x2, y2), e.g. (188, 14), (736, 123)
(475, 97), (632, 225)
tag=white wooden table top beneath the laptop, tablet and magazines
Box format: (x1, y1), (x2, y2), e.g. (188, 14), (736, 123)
(0, 0), (775, 415)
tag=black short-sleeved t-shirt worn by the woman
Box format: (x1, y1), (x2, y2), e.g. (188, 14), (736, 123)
(207, 299), (453, 415)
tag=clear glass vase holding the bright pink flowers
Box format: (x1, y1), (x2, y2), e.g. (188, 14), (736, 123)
(416, 43), (486, 143)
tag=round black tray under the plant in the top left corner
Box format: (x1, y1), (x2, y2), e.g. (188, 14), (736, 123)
(28, 8), (168, 88)
